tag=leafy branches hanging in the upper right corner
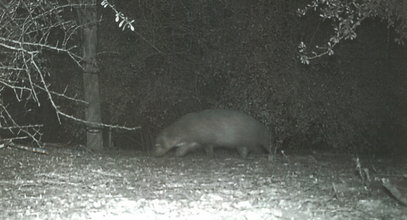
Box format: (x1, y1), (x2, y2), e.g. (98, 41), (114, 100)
(297, 0), (407, 64)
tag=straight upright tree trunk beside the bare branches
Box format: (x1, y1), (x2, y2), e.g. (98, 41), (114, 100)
(78, 0), (103, 150)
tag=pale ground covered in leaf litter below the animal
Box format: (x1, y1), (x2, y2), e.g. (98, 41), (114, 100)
(0, 144), (407, 220)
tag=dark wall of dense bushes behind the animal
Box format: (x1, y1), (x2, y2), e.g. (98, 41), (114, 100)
(34, 0), (407, 153)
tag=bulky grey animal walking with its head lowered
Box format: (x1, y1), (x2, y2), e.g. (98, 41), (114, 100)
(155, 109), (271, 158)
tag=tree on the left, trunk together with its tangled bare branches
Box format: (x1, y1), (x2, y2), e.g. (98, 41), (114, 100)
(0, 0), (134, 148)
